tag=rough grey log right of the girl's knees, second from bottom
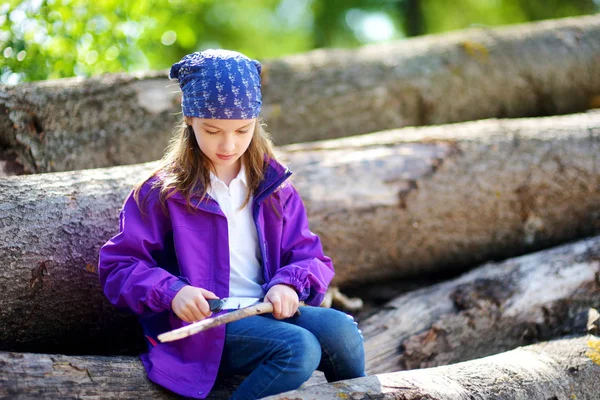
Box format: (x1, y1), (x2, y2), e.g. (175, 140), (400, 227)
(360, 236), (600, 374)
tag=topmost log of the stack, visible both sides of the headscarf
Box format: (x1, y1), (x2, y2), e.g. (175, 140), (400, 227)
(0, 16), (600, 173)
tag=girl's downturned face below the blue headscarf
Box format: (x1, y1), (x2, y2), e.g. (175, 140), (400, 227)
(188, 117), (256, 180)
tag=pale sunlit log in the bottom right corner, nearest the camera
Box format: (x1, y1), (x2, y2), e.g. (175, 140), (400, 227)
(265, 337), (600, 400)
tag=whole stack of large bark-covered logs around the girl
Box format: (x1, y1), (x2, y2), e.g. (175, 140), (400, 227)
(0, 16), (600, 399)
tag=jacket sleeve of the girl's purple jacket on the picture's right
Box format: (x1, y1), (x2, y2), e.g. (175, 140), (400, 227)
(265, 185), (334, 306)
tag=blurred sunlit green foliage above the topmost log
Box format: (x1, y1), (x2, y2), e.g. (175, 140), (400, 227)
(0, 0), (600, 84)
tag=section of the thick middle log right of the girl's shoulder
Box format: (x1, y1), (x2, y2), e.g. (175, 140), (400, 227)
(282, 113), (600, 286)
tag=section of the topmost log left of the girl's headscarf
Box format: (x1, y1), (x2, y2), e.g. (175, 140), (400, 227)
(0, 72), (181, 175)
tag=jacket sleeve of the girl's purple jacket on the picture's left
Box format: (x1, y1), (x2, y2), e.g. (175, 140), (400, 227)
(98, 182), (187, 314)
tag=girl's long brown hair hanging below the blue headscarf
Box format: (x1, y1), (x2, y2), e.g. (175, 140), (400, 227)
(133, 117), (275, 214)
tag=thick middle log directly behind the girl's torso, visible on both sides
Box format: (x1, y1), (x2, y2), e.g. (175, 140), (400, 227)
(0, 113), (600, 354)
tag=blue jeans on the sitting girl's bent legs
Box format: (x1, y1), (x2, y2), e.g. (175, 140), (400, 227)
(219, 306), (365, 400)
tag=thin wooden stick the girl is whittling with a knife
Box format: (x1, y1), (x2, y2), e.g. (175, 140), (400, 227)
(158, 301), (305, 343)
